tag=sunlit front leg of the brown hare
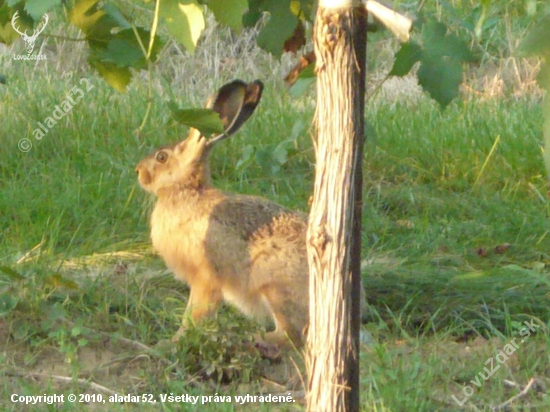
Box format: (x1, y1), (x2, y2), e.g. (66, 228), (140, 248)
(172, 279), (223, 342)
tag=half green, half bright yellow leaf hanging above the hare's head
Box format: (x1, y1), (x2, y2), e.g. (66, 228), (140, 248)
(160, 0), (205, 53)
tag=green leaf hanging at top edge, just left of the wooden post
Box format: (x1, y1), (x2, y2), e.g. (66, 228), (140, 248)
(257, 0), (298, 57)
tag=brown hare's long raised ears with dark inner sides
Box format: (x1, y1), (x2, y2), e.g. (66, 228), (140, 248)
(206, 80), (264, 148)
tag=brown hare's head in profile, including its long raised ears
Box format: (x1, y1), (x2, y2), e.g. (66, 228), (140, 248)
(136, 80), (263, 194)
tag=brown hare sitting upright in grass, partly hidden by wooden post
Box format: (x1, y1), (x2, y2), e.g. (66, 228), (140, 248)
(136, 80), (309, 346)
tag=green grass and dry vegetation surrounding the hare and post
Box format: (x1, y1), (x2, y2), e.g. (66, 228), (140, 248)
(0, 0), (550, 411)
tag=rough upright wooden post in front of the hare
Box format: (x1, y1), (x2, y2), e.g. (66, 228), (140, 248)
(307, 0), (367, 412)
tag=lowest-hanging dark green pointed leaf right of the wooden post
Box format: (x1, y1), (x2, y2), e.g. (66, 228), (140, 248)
(417, 55), (462, 108)
